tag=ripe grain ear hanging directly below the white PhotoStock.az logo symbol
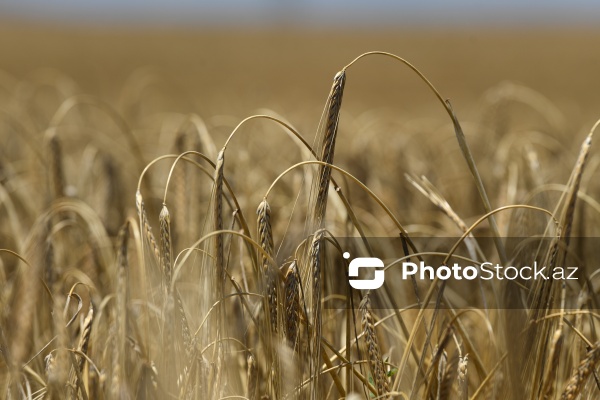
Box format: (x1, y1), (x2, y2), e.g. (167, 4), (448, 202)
(359, 294), (390, 397)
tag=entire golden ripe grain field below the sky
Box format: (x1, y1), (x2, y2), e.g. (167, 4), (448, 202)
(0, 23), (600, 400)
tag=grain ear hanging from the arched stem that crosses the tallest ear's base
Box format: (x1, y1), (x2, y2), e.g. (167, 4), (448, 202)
(256, 199), (278, 332)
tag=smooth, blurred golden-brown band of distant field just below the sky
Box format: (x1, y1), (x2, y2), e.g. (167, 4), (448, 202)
(0, 22), (600, 123)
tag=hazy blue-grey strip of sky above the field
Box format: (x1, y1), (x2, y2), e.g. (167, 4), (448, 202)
(0, 0), (600, 26)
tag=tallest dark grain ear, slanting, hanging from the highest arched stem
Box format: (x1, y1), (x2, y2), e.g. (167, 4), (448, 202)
(314, 70), (346, 228)
